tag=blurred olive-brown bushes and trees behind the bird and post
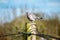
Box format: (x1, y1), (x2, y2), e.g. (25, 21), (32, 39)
(0, 13), (60, 40)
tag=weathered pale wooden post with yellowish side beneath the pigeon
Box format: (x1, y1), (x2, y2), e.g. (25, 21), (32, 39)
(27, 22), (36, 40)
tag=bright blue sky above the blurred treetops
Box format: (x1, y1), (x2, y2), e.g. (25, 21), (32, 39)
(0, 0), (60, 23)
